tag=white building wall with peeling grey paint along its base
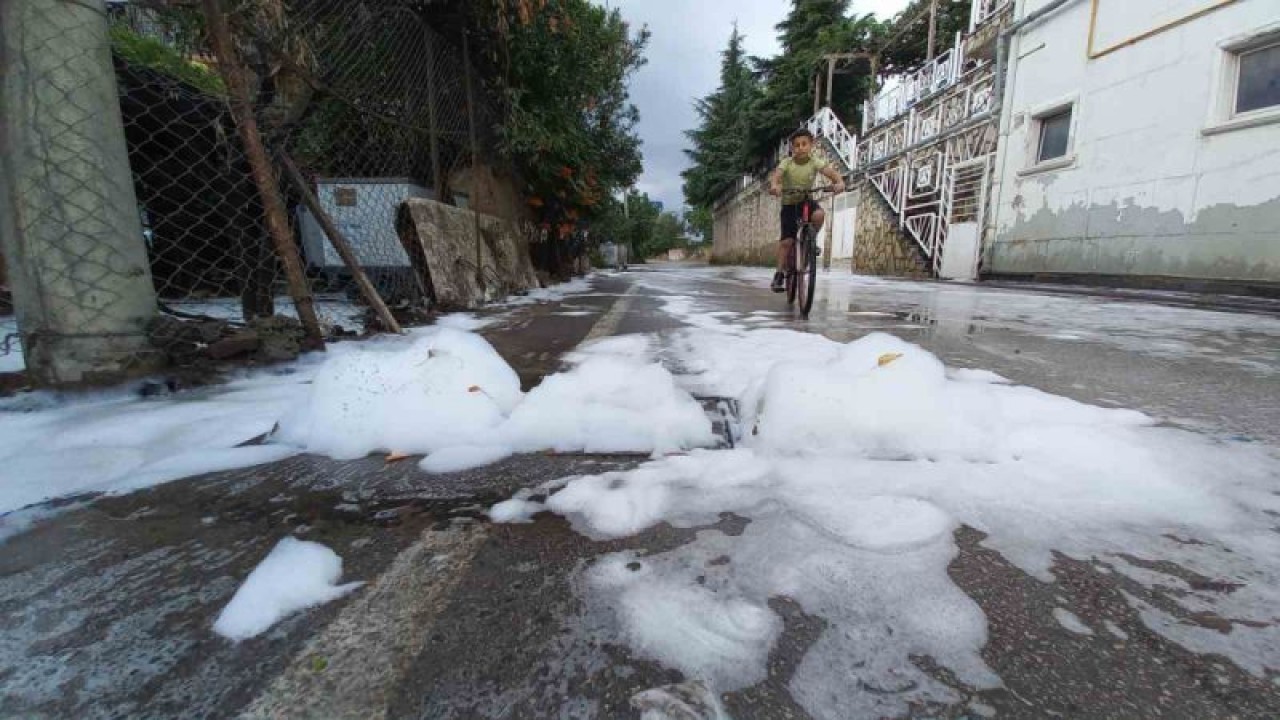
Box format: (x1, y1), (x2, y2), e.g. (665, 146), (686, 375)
(984, 0), (1280, 283)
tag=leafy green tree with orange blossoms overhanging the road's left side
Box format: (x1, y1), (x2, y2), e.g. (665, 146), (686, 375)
(472, 0), (649, 243)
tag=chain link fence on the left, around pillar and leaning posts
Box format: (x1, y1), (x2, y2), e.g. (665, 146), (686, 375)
(0, 0), (515, 381)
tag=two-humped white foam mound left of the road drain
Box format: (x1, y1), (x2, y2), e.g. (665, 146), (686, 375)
(273, 328), (716, 473)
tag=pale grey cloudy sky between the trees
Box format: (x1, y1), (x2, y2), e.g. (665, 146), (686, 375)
(596, 0), (909, 210)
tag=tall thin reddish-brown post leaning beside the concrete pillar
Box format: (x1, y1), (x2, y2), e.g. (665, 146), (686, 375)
(201, 0), (324, 350)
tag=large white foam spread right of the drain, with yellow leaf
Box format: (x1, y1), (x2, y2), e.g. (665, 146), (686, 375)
(488, 295), (1280, 717)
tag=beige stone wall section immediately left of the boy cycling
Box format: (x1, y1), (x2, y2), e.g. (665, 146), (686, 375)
(712, 182), (782, 265)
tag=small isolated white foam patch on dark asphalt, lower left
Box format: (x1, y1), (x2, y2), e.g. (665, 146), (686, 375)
(214, 538), (364, 641)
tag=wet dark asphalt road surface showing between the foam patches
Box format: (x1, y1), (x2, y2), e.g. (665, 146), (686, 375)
(0, 266), (1280, 719)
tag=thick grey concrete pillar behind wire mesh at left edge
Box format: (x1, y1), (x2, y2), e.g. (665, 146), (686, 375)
(0, 0), (157, 384)
